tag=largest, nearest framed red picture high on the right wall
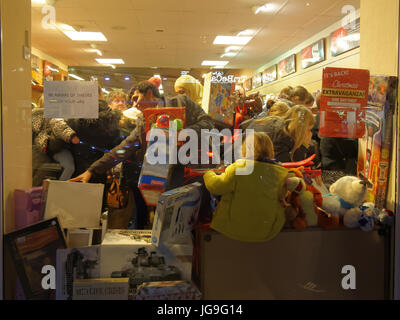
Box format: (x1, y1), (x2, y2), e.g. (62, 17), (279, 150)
(331, 18), (360, 57)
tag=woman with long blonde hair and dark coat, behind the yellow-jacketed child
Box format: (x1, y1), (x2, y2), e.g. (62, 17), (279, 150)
(248, 105), (315, 162)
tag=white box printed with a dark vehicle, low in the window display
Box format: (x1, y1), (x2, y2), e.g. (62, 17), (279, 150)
(100, 230), (193, 292)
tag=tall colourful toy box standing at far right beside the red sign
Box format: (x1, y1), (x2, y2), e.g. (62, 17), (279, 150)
(357, 76), (397, 209)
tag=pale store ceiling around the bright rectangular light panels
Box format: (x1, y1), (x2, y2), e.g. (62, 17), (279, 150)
(32, 0), (360, 70)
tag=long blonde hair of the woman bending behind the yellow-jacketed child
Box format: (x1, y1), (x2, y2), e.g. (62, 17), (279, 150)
(283, 105), (315, 160)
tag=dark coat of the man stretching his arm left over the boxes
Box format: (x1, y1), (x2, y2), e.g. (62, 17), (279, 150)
(89, 95), (213, 180)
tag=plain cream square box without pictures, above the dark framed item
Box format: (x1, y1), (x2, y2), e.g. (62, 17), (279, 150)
(42, 180), (104, 229)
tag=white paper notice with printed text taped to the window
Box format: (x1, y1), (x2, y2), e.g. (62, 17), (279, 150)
(43, 80), (99, 119)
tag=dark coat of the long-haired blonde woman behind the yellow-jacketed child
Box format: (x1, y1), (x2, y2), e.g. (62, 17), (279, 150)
(248, 117), (315, 162)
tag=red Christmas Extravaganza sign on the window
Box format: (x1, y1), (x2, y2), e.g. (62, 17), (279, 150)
(319, 68), (369, 139)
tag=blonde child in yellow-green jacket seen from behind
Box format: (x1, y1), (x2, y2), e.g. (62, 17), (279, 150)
(204, 132), (288, 242)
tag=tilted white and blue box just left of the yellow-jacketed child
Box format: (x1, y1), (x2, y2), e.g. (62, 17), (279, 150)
(152, 182), (202, 246)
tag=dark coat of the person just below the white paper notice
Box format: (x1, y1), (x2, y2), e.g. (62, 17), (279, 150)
(67, 100), (121, 174)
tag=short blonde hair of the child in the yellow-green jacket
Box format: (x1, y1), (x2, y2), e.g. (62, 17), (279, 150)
(242, 132), (275, 161)
